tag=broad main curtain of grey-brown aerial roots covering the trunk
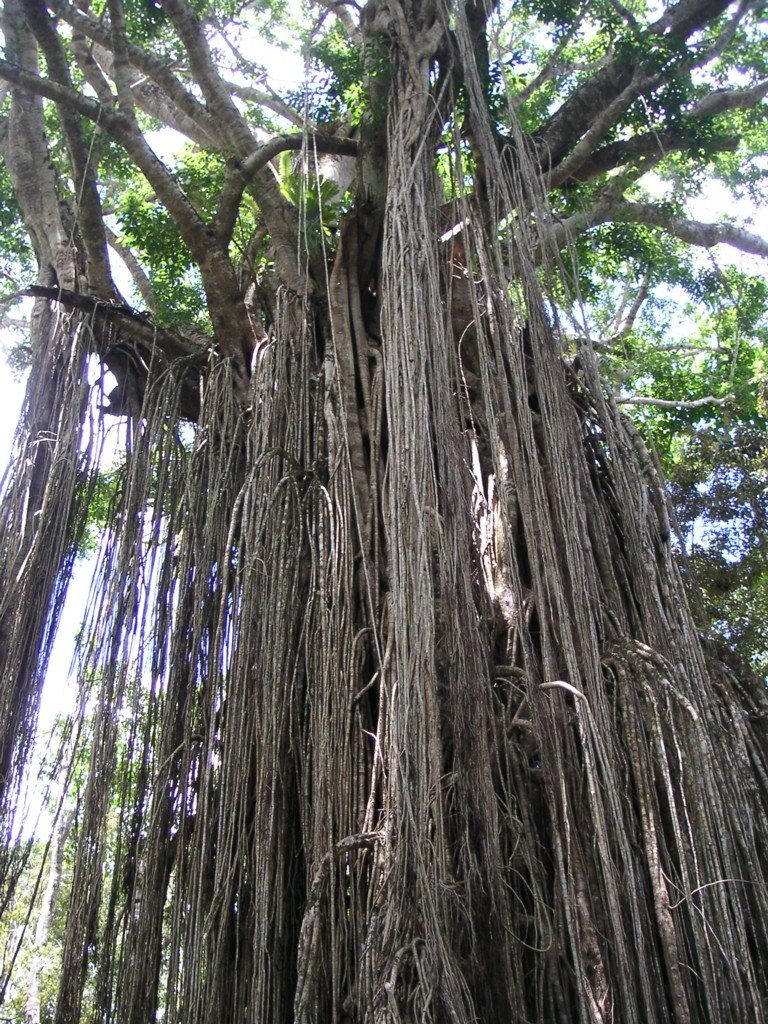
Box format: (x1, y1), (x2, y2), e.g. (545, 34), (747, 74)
(0, 2), (768, 1024)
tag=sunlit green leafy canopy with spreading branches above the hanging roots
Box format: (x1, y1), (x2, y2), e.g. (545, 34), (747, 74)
(2, 2), (768, 667)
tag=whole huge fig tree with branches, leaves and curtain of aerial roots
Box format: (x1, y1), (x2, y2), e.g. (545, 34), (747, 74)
(0, 0), (768, 1024)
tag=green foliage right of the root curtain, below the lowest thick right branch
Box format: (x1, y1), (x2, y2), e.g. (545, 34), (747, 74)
(577, 252), (768, 674)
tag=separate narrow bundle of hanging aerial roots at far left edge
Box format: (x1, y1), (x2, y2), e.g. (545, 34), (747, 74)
(0, 304), (100, 864)
